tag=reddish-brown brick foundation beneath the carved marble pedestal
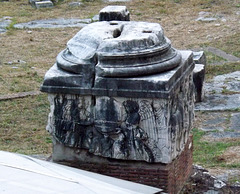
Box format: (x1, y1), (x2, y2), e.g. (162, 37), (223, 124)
(58, 136), (193, 193)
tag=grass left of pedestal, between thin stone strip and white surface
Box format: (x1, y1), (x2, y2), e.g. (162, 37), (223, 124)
(0, 94), (52, 154)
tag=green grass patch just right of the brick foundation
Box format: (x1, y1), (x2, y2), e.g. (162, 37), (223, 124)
(193, 129), (240, 168)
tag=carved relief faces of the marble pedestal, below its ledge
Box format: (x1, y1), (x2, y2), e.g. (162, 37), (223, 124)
(47, 70), (194, 163)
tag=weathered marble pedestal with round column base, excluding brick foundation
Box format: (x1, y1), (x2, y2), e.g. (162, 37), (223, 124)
(41, 21), (194, 163)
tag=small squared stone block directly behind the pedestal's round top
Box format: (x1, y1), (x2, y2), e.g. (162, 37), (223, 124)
(99, 6), (130, 21)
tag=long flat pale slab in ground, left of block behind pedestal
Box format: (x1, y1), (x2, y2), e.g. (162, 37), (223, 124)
(14, 18), (92, 29)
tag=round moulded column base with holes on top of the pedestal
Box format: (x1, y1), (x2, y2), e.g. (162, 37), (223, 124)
(57, 21), (181, 77)
